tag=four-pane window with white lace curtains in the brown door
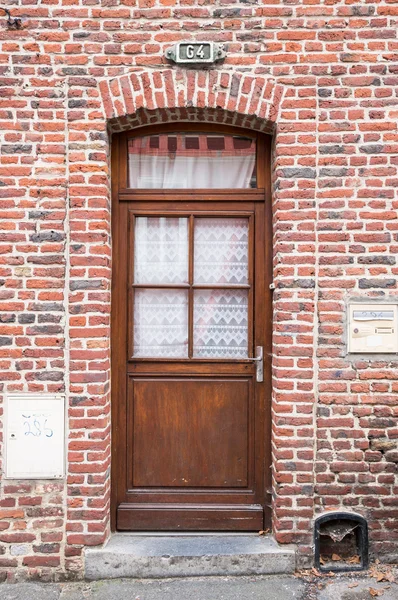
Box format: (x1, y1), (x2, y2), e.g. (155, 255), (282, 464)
(132, 215), (251, 359)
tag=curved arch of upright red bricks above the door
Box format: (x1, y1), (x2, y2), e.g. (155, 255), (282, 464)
(99, 69), (284, 133)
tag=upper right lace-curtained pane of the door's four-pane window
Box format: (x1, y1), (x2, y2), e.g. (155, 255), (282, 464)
(194, 217), (249, 285)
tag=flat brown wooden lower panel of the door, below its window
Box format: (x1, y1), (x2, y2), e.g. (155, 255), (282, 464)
(128, 378), (251, 488)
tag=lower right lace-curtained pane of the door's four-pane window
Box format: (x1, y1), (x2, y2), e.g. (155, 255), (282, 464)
(193, 289), (248, 358)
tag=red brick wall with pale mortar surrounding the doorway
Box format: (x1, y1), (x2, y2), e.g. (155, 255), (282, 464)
(0, 0), (398, 580)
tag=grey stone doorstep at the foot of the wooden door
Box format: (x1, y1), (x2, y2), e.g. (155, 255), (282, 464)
(85, 533), (295, 581)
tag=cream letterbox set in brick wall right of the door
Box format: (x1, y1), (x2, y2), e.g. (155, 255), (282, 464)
(348, 303), (398, 354)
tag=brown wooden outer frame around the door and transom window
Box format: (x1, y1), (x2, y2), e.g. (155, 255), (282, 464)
(110, 121), (273, 533)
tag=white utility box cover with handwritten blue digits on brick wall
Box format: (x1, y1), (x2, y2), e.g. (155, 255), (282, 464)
(5, 394), (65, 479)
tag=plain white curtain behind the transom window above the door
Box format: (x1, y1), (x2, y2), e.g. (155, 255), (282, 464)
(129, 153), (255, 189)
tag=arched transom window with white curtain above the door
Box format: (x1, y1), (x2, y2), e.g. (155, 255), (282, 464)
(128, 132), (257, 190)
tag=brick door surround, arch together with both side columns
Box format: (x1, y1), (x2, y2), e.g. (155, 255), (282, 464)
(66, 68), (315, 570)
